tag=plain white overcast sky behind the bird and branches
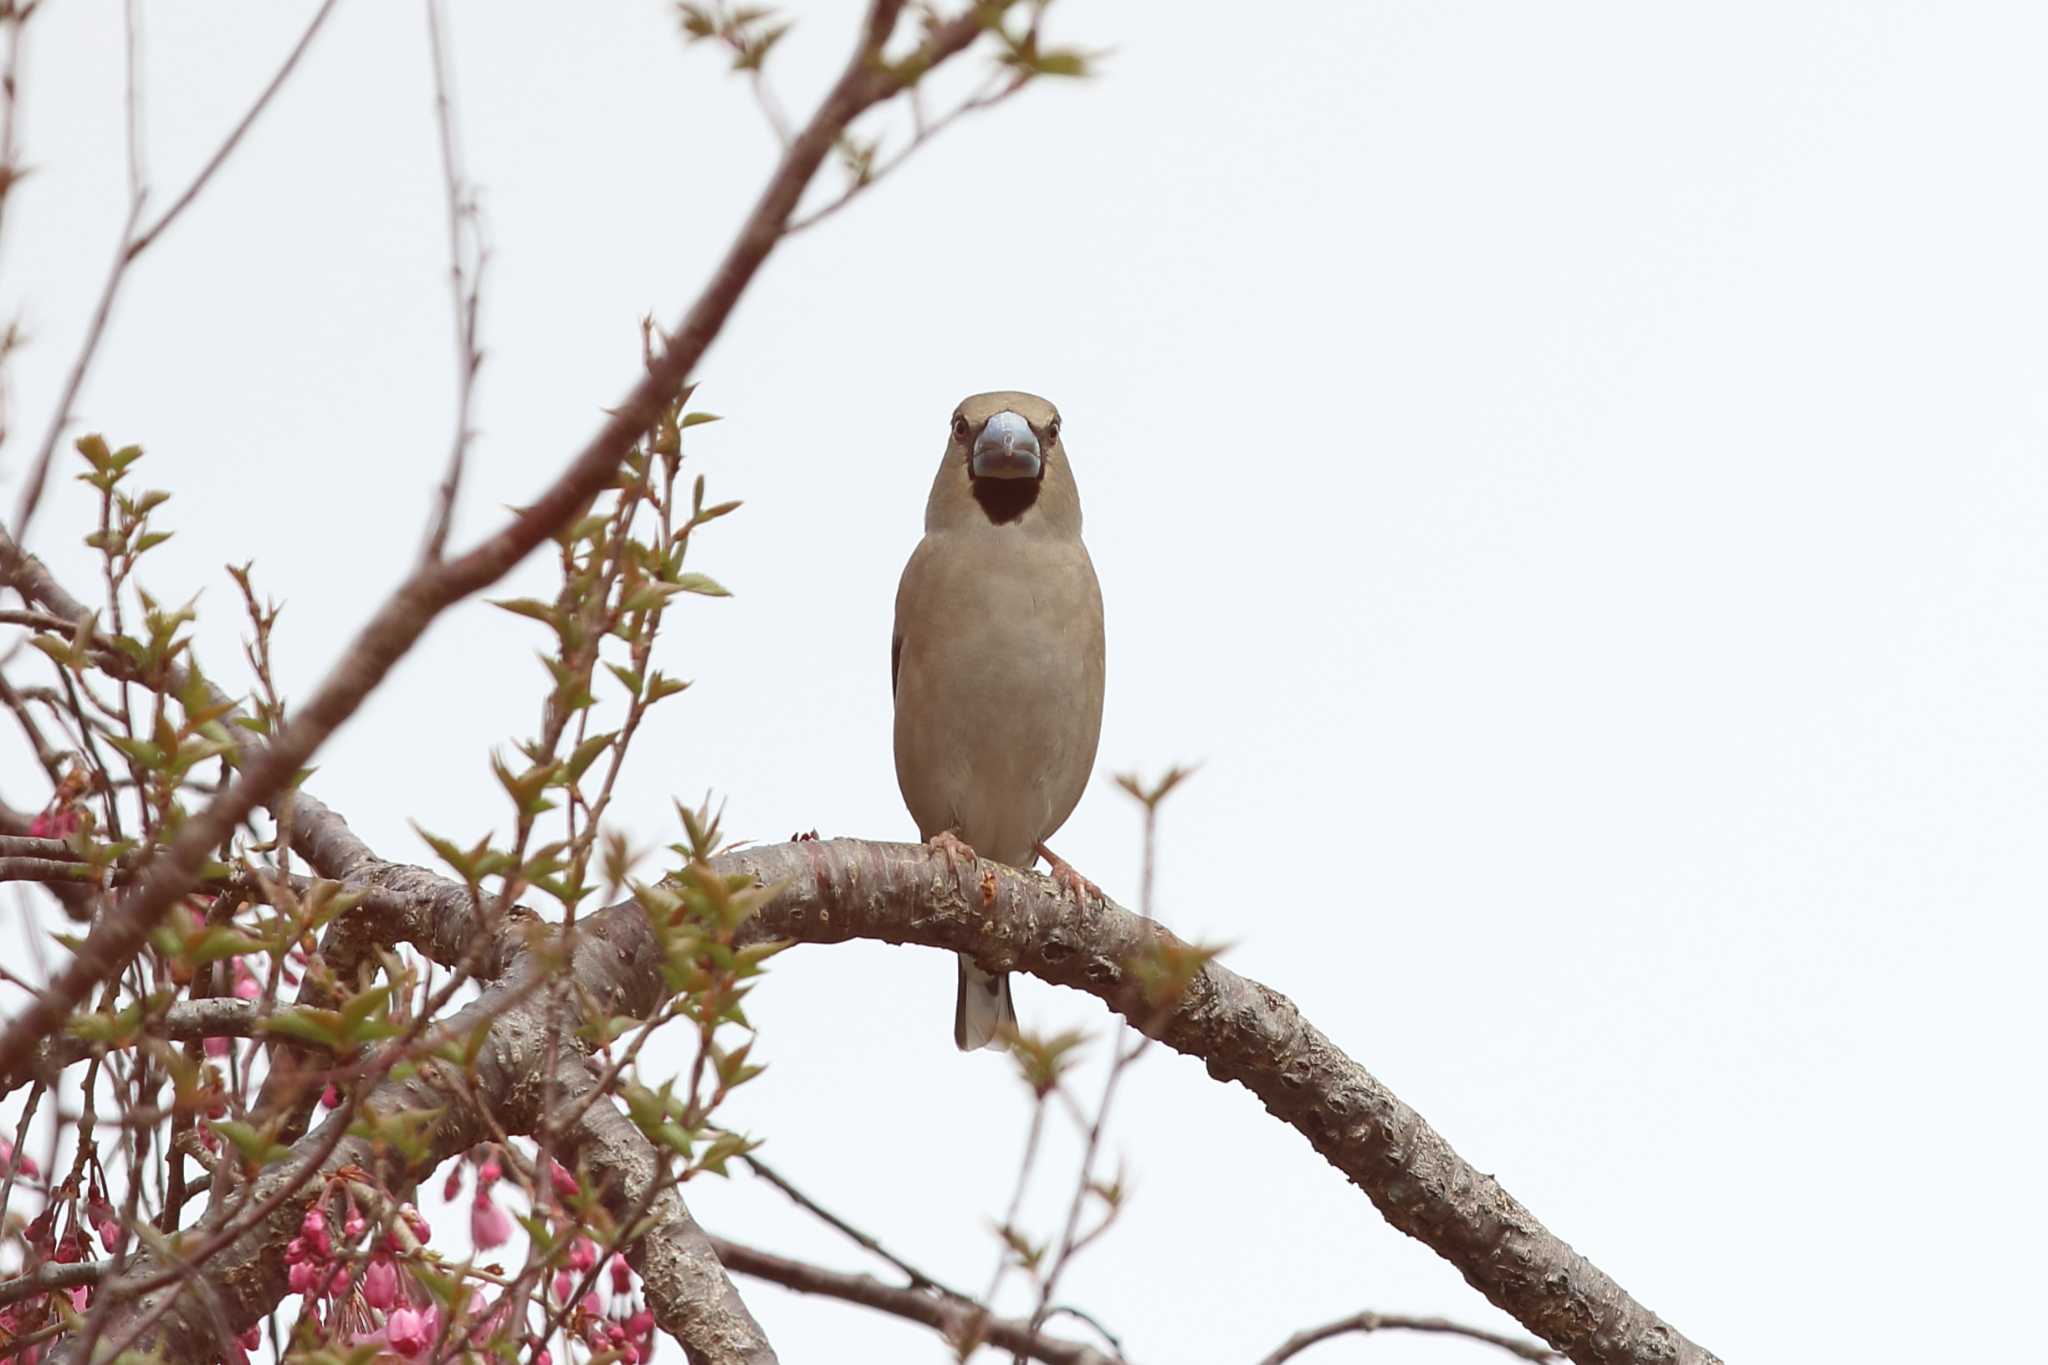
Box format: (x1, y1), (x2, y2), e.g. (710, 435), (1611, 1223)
(0, 0), (2048, 1363)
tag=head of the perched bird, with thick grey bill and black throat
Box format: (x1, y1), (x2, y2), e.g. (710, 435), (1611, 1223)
(928, 389), (1081, 532)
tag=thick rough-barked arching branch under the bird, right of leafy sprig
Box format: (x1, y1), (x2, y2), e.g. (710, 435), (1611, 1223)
(719, 839), (1716, 1365)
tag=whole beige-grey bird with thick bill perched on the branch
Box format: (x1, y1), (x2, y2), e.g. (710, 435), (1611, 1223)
(889, 391), (1104, 1052)
